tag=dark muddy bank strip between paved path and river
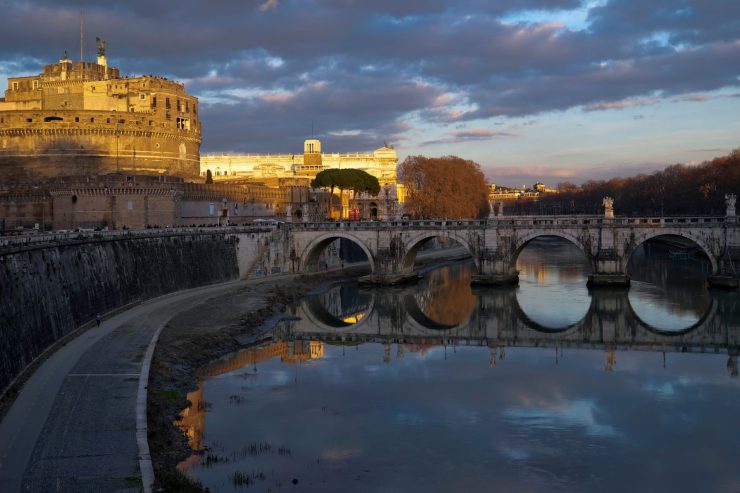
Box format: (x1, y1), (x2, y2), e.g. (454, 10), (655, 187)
(147, 269), (358, 491)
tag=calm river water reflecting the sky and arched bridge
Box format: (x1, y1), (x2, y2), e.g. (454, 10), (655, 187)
(181, 239), (740, 492)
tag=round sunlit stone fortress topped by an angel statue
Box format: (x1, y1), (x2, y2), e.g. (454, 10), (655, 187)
(0, 39), (201, 183)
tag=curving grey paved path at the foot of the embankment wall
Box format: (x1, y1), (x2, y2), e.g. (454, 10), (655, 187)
(0, 282), (249, 493)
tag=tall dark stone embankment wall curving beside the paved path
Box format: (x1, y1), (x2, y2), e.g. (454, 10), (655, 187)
(0, 228), (275, 395)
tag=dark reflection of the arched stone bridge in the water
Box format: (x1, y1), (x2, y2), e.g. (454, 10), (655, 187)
(275, 288), (740, 376)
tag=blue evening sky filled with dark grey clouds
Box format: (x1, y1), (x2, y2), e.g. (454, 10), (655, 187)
(0, 0), (740, 186)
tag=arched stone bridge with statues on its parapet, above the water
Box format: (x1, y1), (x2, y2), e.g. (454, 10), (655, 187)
(286, 208), (740, 288)
